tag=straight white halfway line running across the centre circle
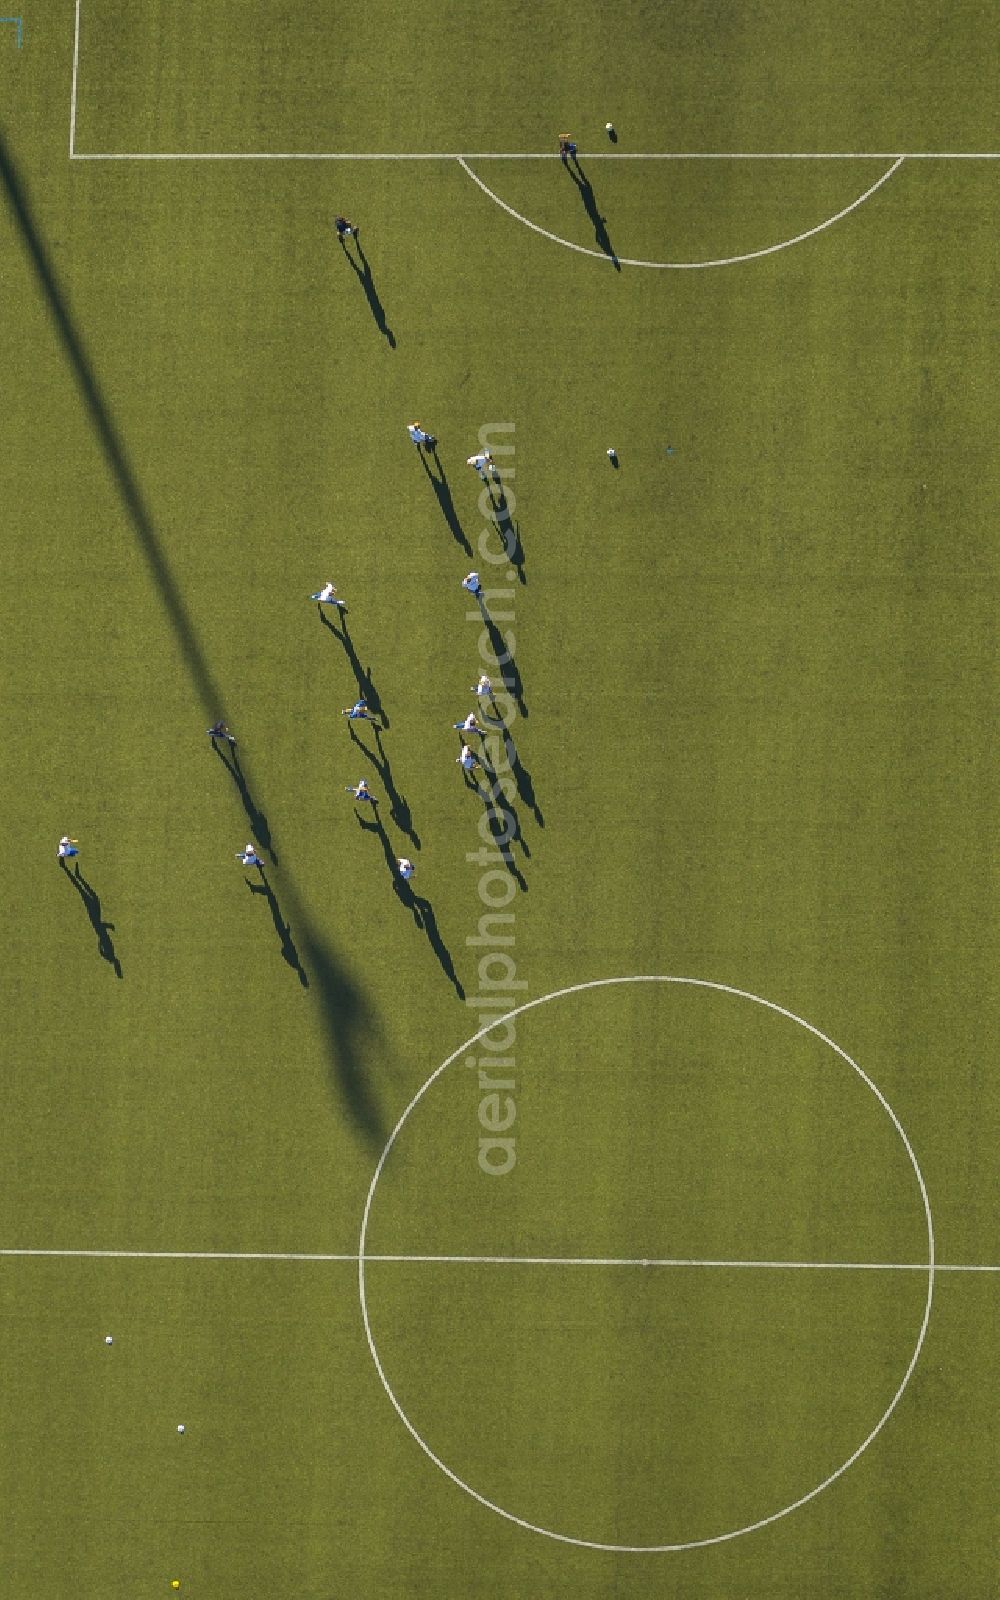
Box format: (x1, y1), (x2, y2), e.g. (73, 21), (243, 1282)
(0, 1248), (1000, 1272)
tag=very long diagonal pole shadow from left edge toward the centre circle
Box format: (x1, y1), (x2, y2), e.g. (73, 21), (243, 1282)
(0, 134), (390, 1150)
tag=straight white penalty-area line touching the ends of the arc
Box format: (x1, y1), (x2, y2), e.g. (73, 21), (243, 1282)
(70, 151), (1000, 162)
